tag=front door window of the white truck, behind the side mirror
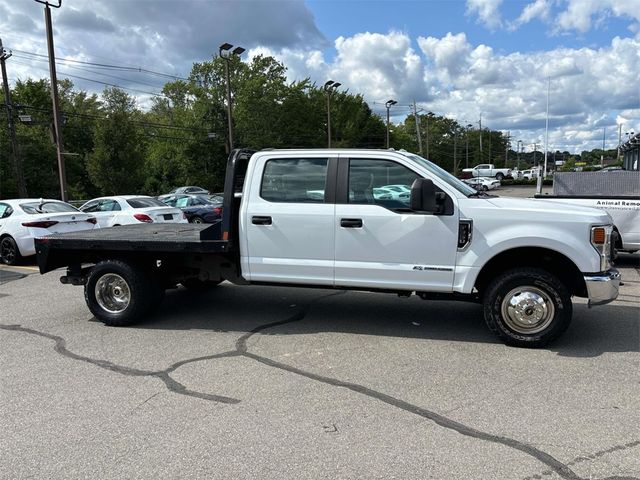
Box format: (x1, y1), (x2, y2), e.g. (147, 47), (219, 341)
(349, 159), (419, 209)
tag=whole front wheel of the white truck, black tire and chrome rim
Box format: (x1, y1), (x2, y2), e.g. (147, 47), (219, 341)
(484, 268), (573, 348)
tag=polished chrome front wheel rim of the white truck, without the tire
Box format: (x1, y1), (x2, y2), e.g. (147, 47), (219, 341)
(501, 286), (555, 335)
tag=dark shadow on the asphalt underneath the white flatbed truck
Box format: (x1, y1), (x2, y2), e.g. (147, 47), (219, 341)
(126, 276), (640, 357)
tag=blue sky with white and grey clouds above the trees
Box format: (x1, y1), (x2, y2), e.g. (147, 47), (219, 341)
(0, 0), (640, 153)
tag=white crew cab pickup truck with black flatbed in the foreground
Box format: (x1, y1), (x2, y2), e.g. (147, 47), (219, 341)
(36, 149), (620, 347)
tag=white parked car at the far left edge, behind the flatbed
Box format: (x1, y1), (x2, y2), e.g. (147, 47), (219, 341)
(0, 198), (96, 265)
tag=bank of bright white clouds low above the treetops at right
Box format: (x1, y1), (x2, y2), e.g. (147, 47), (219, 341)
(258, 32), (640, 151)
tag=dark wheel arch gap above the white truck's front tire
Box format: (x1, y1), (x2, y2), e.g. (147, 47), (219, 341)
(474, 247), (587, 297)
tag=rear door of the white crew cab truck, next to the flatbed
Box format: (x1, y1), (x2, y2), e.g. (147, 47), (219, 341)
(241, 153), (337, 285)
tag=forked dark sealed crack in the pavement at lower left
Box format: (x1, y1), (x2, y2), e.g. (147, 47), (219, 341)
(0, 324), (240, 403)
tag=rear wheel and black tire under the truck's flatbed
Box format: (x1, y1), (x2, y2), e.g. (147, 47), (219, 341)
(84, 260), (164, 327)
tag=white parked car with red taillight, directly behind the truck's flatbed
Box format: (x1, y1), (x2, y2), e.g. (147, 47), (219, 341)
(80, 195), (187, 228)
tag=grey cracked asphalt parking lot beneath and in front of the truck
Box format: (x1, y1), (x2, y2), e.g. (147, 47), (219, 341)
(0, 254), (640, 479)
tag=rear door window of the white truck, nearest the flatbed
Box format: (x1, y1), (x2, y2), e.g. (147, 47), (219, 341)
(260, 158), (329, 203)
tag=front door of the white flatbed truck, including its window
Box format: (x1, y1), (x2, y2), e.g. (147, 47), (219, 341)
(335, 158), (458, 292)
